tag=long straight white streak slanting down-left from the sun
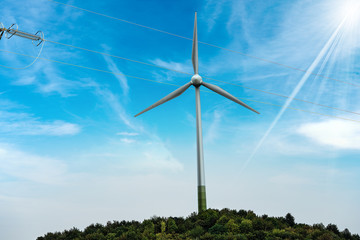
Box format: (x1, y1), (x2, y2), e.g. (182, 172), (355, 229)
(240, 17), (347, 172)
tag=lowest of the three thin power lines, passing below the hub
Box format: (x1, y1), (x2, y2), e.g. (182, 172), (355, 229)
(0, 49), (360, 123)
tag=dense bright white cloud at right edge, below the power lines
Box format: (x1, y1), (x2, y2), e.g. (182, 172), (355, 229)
(297, 120), (360, 150)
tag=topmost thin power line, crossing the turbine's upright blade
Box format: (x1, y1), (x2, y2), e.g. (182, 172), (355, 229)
(48, 0), (360, 87)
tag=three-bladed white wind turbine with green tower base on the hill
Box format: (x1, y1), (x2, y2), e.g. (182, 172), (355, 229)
(135, 12), (259, 212)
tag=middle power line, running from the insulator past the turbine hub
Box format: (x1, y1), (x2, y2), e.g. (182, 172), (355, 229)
(44, 39), (360, 115)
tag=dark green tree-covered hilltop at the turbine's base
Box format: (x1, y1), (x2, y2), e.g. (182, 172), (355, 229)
(37, 208), (360, 240)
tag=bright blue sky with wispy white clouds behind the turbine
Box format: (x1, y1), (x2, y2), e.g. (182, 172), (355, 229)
(0, 0), (360, 240)
